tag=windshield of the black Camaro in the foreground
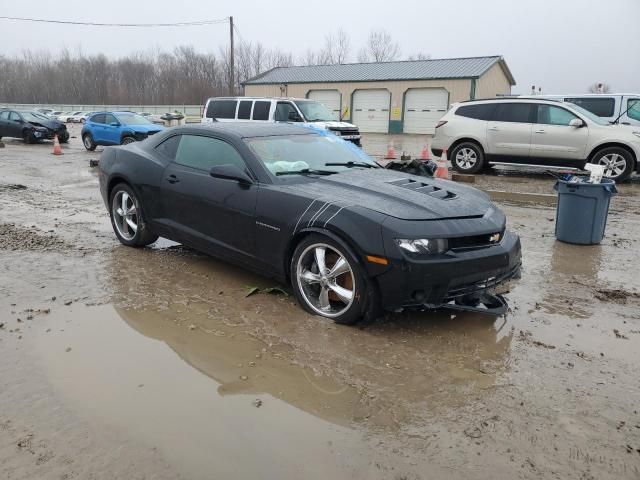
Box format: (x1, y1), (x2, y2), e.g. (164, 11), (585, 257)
(245, 134), (378, 175)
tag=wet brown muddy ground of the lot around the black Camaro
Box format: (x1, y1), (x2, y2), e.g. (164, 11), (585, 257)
(0, 127), (640, 479)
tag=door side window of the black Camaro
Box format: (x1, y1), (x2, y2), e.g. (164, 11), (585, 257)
(175, 135), (246, 172)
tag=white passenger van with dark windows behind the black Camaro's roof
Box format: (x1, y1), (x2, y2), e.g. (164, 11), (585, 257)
(202, 97), (361, 145)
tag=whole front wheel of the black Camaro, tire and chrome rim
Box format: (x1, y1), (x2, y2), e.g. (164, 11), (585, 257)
(290, 234), (364, 325)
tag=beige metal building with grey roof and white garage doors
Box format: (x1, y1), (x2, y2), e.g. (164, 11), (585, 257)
(243, 56), (515, 134)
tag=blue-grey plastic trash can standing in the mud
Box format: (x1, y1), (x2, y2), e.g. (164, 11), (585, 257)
(554, 177), (618, 245)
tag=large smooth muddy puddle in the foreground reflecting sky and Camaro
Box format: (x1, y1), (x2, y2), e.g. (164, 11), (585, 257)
(36, 305), (440, 479)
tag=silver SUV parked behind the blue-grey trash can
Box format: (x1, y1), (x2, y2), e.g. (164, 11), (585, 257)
(431, 98), (640, 181)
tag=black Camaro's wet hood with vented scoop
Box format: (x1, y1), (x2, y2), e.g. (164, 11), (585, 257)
(284, 168), (492, 220)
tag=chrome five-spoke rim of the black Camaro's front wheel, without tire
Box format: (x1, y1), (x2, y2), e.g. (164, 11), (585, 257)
(296, 243), (356, 318)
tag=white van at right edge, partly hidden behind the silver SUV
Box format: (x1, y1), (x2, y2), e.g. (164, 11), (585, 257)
(533, 93), (640, 125)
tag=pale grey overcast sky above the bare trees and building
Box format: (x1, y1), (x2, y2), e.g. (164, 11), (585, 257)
(0, 0), (640, 93)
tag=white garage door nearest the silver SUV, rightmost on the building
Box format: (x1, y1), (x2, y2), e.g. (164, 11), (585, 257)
(403, 88), (449, 134)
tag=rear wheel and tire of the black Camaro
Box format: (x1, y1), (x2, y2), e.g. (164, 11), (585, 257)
(109, 183), (158, 247)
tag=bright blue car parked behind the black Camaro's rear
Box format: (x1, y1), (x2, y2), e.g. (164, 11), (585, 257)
(82, 112), (164, 150)
